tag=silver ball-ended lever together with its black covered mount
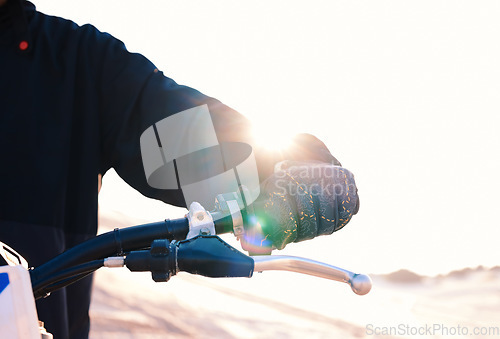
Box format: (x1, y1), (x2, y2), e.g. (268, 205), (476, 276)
(124, 235), (372, 295)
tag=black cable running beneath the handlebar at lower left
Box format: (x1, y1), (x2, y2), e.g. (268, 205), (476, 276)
(31, 259), (104, 299)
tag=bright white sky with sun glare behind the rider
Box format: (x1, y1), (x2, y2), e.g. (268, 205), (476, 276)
(34, 0), (500, 274)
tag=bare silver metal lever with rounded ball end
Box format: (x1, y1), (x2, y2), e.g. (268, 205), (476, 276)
(251, 255), (372, 295)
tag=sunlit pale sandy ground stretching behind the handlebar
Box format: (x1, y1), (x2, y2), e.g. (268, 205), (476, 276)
(91, 213), (500, 339)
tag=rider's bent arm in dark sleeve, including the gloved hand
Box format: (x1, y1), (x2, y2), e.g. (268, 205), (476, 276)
(90, 27), (359, 248)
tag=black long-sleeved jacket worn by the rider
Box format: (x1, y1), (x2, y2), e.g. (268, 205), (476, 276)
(0, 0), (254, 338)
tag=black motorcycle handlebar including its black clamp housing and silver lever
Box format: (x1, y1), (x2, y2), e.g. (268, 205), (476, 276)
(30, 216), (371, 297)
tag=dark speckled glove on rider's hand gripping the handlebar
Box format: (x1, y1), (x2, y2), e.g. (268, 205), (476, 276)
(254, 161), (359, 249)
